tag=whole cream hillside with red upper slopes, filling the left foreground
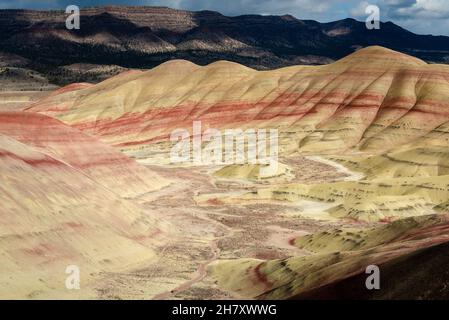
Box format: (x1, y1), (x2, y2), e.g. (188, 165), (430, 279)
(0, 112), (166, 298)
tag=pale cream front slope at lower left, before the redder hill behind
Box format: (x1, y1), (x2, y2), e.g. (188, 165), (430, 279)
(0, 133), (164, 298)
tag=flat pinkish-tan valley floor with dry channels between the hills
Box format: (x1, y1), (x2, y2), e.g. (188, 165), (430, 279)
(92, 157), (372, 299)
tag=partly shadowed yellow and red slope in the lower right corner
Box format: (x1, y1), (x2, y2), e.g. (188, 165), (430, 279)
(210, 215), (449, 299)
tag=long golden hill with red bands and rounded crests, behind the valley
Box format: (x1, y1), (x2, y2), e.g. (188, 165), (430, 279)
(29, 47), (449, 157)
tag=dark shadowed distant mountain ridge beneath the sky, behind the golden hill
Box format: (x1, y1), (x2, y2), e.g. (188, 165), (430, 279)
(0, 6), (449, 85)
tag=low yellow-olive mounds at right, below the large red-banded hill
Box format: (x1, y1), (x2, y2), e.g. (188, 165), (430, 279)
(198, 146), (449, 221)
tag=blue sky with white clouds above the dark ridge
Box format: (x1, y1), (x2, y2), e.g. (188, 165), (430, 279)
(0, 0), (449, 35)
